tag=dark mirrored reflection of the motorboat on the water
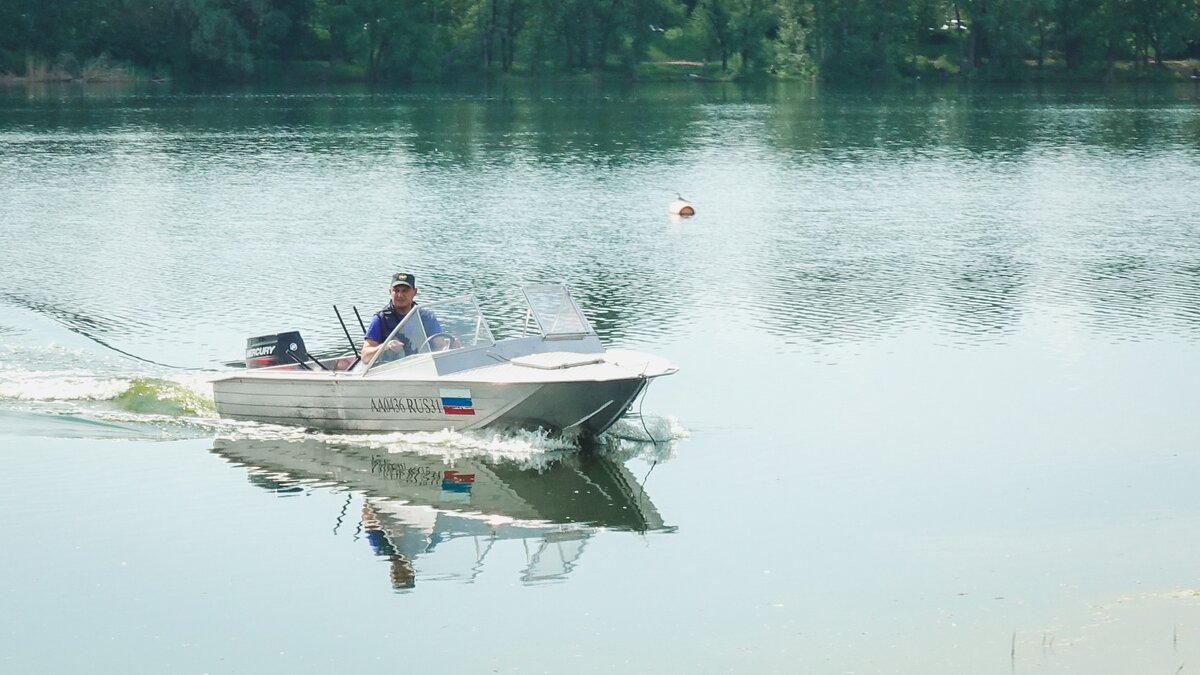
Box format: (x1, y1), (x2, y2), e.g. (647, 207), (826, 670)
(212, 438), (672, 590)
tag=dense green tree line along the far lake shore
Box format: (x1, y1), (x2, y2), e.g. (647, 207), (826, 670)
(0, 0), (1200, 82)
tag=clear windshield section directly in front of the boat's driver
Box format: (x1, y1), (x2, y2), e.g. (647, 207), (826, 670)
(367, 295), (496, 369)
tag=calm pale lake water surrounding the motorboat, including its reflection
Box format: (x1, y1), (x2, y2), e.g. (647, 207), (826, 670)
(0, 84), (1200, 675)
